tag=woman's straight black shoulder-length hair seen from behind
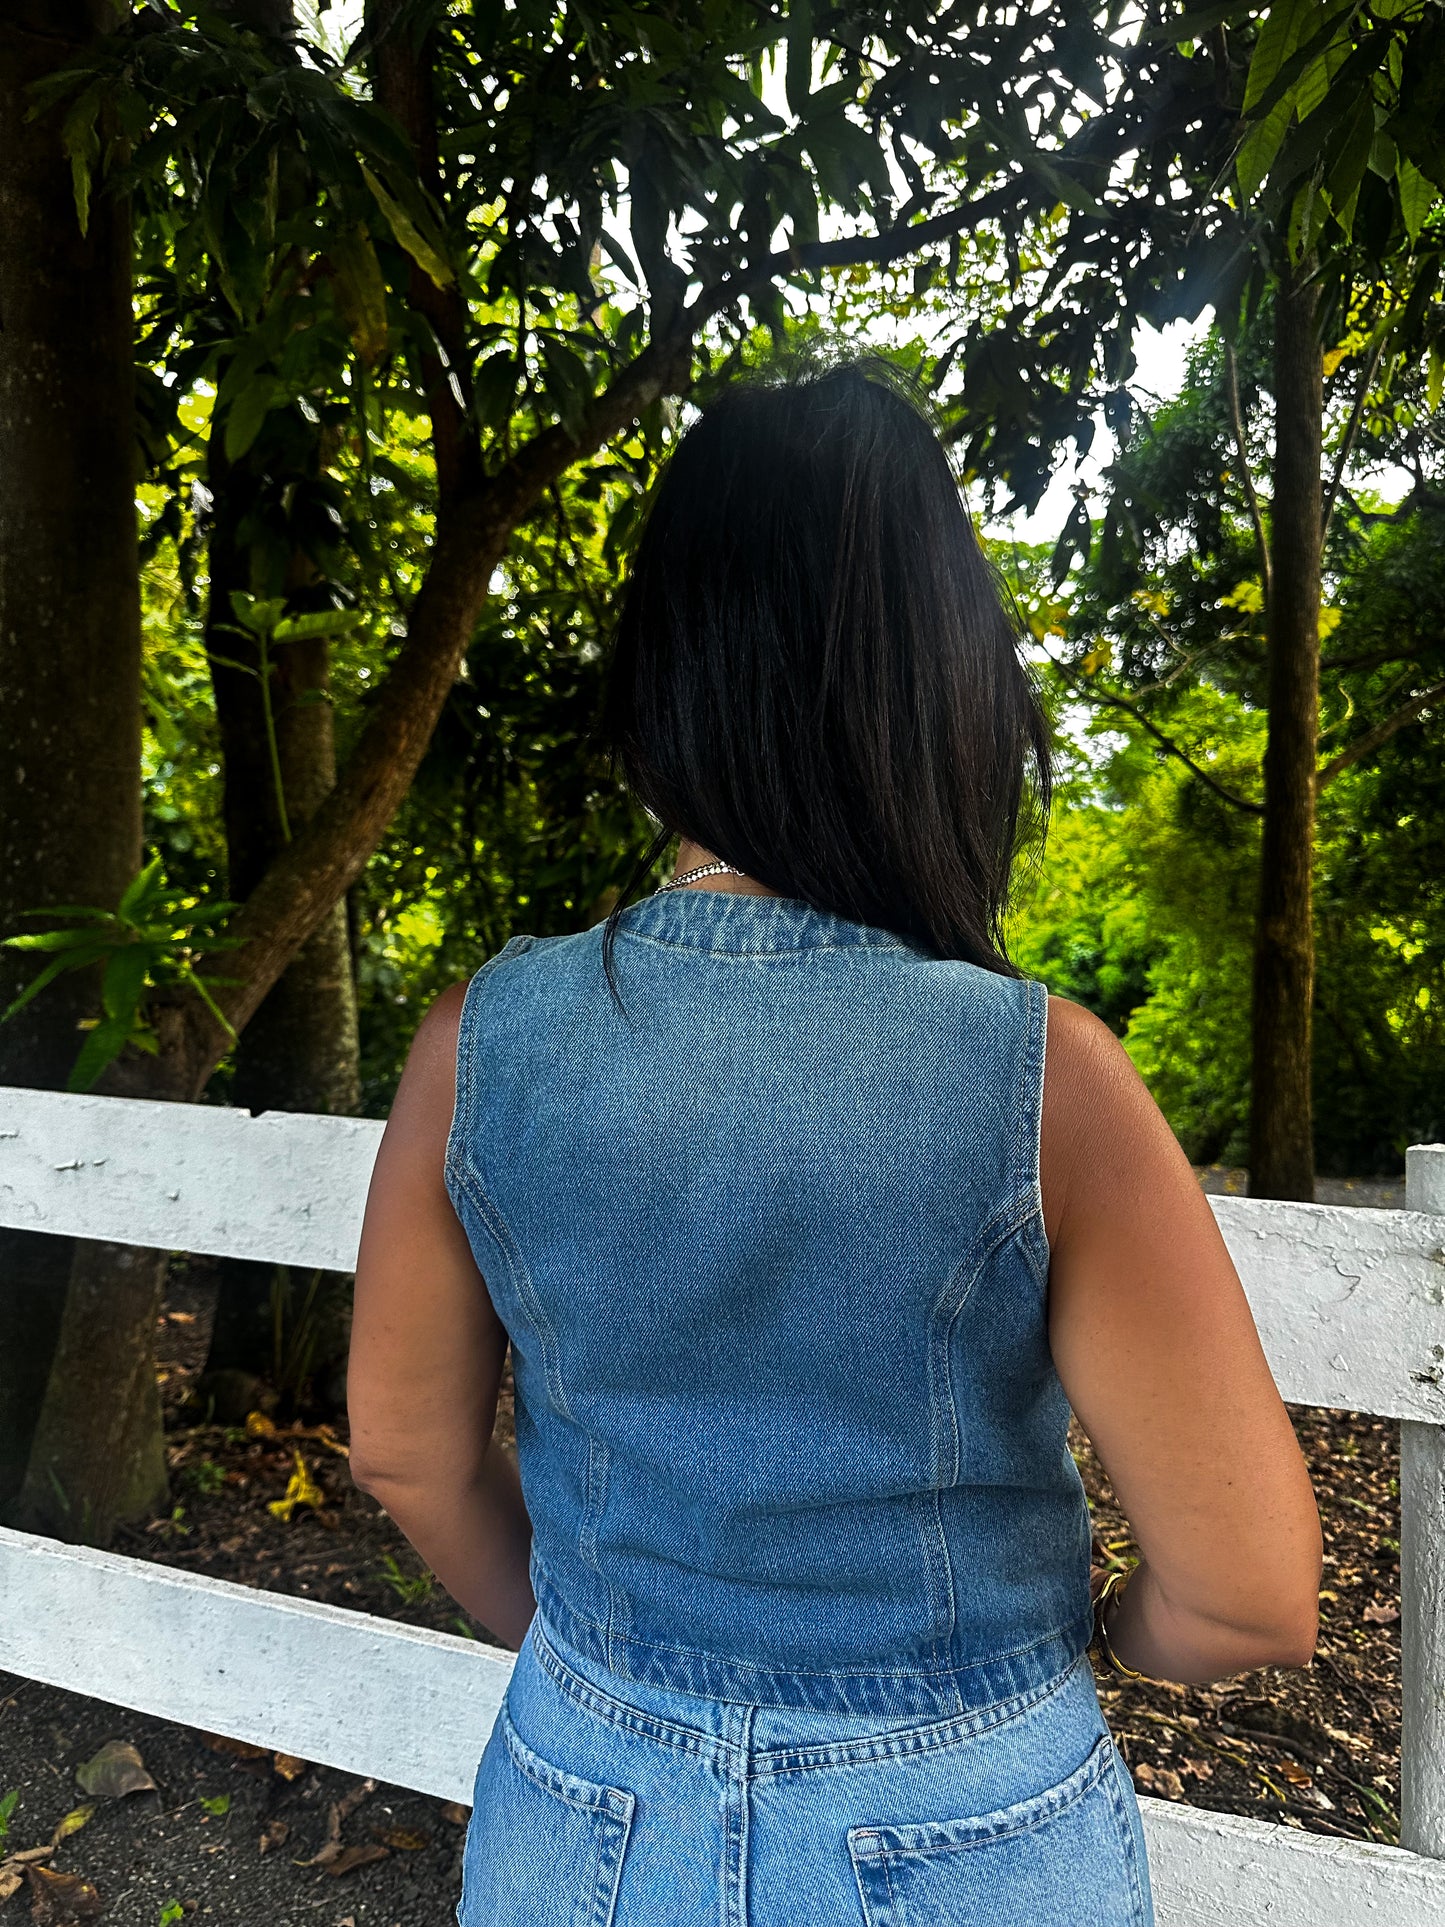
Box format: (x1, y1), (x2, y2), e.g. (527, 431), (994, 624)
(599, 358), (1052, 994)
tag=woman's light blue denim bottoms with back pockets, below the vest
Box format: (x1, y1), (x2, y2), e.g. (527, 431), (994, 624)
(457, 1617), (1154, 1927)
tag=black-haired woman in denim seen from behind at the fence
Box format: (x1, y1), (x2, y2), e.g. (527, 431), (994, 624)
(351, 364), (1320, 1927)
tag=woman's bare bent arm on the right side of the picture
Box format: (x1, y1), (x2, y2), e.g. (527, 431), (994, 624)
(1040, 996), (1322, 1682)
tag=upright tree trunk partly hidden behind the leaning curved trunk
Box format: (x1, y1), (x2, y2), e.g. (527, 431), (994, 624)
(206, 445), (360, 1397)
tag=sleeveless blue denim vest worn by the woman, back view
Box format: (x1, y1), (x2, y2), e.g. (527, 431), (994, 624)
(447, 890), (1090, 1717)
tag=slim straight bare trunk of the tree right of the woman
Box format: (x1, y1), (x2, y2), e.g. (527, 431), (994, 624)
(1248, 266), (1324, 1201)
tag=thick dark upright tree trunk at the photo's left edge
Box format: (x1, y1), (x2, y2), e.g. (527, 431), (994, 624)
(0, 0), (154, 1507)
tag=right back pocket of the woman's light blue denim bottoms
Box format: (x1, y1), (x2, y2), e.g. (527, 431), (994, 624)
(848, 1734), (1150, 1927)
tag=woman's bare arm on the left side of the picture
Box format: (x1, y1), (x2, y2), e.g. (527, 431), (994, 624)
(347, 985), (536, 1650)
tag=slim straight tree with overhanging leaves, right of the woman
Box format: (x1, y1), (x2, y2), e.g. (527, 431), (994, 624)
(940, 0), (1445, 1199)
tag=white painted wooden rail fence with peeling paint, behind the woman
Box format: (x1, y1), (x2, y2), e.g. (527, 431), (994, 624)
(0, 1087), (1445, 1927)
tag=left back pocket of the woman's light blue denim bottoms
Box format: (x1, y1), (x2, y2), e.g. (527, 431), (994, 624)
(457, 1705), (638, 1927)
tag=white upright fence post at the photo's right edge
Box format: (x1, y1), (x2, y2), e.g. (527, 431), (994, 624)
(1401, 1145), (1445, 1860)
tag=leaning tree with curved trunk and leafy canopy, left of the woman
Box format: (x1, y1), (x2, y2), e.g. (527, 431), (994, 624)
(2, 0), (1156, 1538)
